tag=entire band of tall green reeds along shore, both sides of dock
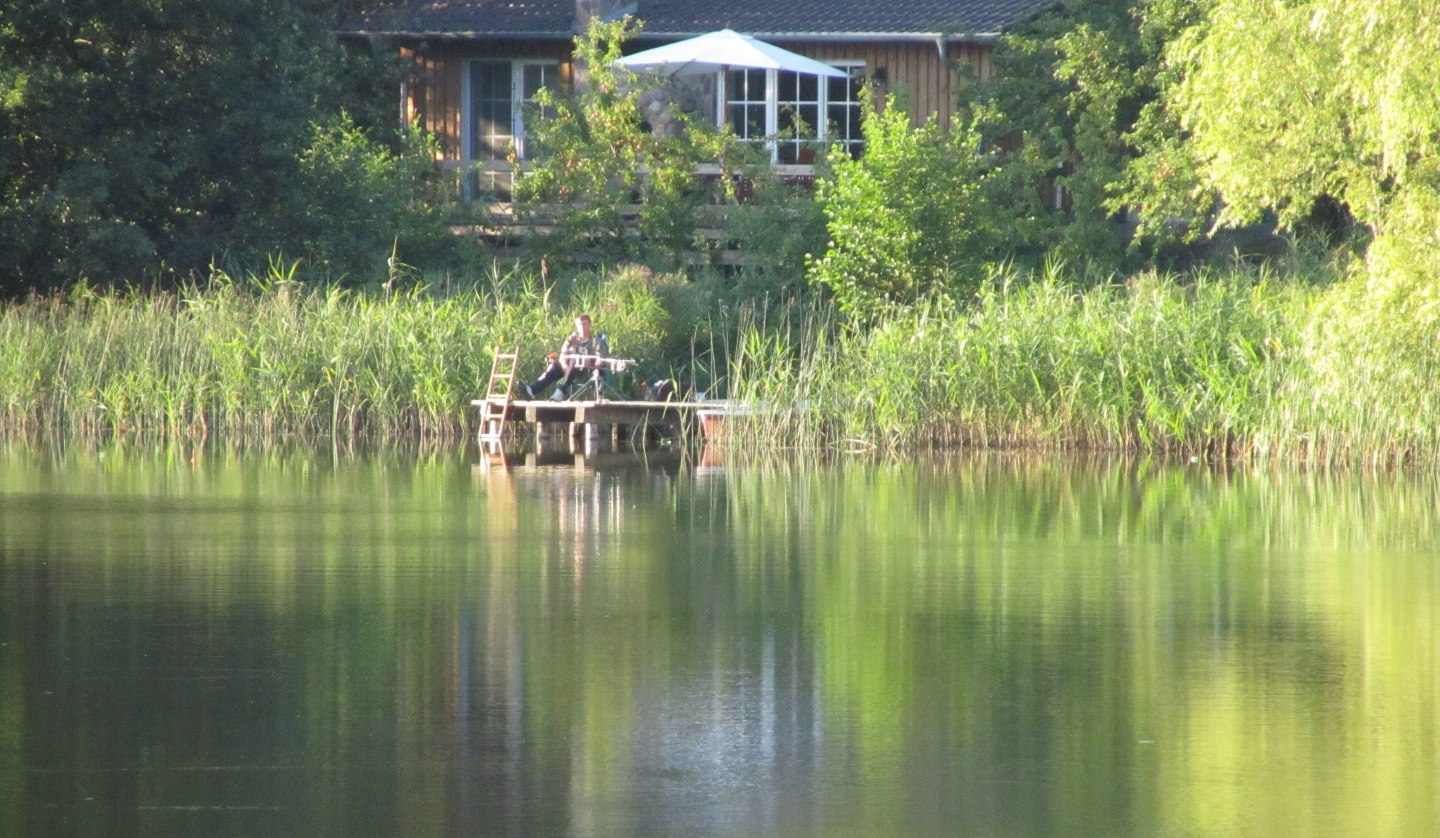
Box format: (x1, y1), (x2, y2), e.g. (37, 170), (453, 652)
(8, 256), (1440, 467)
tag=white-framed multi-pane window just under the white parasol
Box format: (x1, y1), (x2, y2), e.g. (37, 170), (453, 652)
(721, 62), (865, 163)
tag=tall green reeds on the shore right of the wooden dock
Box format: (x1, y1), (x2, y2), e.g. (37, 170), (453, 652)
(729, 266), (1440, 464)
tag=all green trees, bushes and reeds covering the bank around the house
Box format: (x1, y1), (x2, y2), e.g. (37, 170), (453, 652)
(11, 6), (1440, 468)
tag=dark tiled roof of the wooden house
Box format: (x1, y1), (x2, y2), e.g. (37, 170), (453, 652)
(344, 0), (1054, 40)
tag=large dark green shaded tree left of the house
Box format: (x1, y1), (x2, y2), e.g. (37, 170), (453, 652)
(0, 0), (417, 294)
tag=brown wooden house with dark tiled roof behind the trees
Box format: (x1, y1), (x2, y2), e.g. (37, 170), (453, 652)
(343, 0), (1053, 194)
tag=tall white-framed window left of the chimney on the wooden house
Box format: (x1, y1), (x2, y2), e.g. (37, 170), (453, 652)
(462, 60), (560, 197)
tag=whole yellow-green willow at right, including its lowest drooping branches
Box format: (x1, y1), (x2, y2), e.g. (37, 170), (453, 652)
(1174, 0), (1440, 438)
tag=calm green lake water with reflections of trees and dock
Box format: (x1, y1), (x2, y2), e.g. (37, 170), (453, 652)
(0, 443), (1440, 837)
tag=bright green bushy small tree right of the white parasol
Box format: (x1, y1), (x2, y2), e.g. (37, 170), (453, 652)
(809, 88), (1002, 315)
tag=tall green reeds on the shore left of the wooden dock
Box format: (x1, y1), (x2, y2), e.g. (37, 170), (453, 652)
(0, 269), (649, 441)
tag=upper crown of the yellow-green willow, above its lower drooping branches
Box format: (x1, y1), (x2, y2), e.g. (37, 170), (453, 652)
(1175, 0), (1440, 241)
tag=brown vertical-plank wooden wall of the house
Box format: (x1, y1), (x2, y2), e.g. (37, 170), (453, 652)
(400, 40), (991, 161)
